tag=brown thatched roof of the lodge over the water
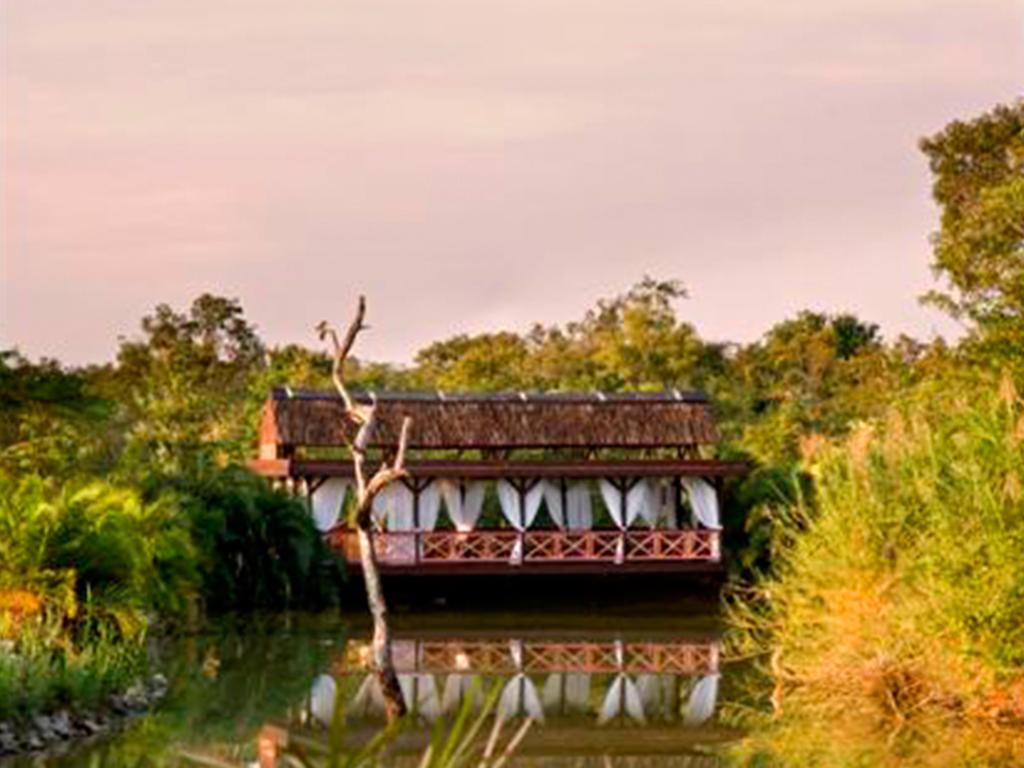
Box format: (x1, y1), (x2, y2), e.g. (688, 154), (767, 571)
(260, 388), (717, 450)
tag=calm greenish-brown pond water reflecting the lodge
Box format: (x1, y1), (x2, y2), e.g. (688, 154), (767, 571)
(5, 607), (739, 768)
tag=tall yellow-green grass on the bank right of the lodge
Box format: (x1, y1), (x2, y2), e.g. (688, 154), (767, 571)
(729, 382), (1024, 745)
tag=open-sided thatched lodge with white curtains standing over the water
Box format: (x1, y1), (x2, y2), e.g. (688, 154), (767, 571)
(251, 388), (745, 578)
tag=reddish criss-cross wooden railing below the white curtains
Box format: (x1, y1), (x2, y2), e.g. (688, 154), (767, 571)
(329, 528), (721, 565)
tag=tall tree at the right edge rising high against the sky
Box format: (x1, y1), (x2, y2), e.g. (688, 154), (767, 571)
(921, 101), (1024, 358)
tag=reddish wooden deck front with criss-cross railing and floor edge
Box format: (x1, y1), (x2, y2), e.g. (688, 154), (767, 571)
(328, 528), (721, 573)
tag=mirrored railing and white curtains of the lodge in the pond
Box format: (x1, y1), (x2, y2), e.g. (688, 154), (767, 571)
(309, 639), (719, 728)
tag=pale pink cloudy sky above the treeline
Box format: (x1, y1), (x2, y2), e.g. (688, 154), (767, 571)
(0, 0), (1024, 362)
